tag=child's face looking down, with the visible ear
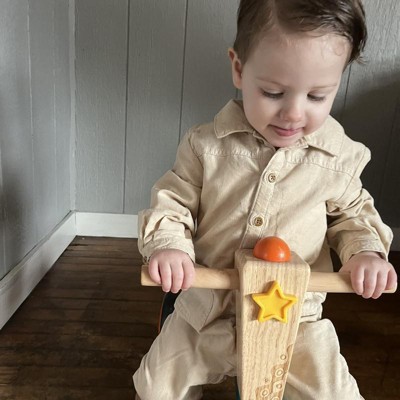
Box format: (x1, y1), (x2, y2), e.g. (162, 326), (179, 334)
(229, 32), (350, 147)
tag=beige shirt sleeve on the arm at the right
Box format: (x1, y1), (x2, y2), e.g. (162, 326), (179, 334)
(327, 147), (393, 263)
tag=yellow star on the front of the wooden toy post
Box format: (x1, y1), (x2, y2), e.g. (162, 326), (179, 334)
(251, 281), (297, 323)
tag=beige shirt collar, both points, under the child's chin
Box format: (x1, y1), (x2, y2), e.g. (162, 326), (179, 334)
(214, 100), (343, 156)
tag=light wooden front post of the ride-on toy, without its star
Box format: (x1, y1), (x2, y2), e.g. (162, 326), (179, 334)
(235, 250), (310, 400)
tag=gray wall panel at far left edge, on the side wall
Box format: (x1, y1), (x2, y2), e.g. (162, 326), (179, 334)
(0, 0), (36, 273)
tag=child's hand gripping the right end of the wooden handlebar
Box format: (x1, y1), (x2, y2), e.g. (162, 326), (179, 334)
(340, 251), (397, 299)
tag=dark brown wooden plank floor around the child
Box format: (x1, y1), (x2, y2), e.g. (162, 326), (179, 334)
(0, 237), (400, 400)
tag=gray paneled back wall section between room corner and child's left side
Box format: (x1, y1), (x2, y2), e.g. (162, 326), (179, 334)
(76, 0), (237, 214)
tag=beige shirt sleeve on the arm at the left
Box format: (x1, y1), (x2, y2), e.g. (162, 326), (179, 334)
(138, 133), (203, 261)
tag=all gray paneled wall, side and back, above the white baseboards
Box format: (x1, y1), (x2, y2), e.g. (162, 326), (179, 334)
(0, 0), (400, 277)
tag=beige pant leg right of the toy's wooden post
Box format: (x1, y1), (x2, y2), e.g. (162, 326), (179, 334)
(285, 319), (362, 400)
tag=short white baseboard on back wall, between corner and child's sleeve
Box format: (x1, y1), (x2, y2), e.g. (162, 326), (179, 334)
(76, 212), (138, 238)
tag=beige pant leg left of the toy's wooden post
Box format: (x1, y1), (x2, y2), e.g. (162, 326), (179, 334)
(133, 312), (236, 400)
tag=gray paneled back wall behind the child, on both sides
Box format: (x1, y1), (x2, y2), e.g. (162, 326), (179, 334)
(76, 0), (400, 227)
